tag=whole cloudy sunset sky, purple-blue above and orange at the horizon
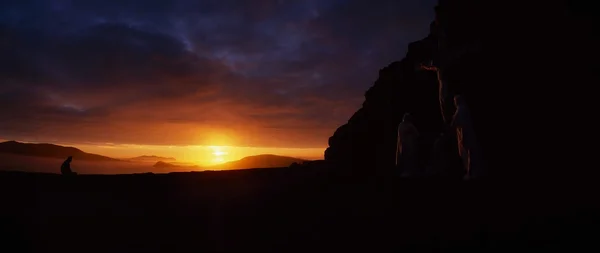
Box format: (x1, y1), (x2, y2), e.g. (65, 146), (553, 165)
(0, 0), (435, 164)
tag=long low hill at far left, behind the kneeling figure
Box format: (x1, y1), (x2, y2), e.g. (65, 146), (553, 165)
(0, 141), (120, 161)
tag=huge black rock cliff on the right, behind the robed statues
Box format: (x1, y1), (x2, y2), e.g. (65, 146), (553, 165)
(325, 0), (600, 177)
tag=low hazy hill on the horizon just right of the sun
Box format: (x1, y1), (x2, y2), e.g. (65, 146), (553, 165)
(206, 155), (307, 170)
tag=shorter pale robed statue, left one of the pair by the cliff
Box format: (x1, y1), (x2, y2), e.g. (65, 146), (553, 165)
(396, 113), (419, 176)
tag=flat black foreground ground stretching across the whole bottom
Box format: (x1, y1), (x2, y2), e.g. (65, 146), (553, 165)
(0, 168), (600, 252)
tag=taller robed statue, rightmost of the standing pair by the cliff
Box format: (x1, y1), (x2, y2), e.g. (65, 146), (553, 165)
(452, 95), (485, 178)
